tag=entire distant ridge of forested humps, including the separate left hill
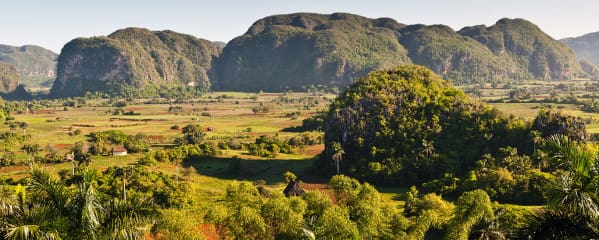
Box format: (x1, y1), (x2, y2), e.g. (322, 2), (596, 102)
(51, 13), (589, 97)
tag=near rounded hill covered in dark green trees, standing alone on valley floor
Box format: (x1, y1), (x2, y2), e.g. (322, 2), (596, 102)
(319, 65), (530, 186)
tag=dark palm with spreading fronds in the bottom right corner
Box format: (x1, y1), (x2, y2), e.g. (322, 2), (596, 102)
(521, 135), (599, 239)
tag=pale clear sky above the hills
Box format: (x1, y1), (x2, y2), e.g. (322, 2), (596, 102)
(0, 0), (599, 53)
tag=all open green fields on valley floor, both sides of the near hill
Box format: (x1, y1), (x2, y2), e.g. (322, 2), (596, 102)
(0, 88), (599, 238)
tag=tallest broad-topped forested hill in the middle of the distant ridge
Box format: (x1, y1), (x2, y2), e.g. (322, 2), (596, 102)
(215, 13), (410, 91)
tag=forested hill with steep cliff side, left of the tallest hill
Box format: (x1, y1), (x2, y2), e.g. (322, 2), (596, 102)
(50, 28), (220, 97)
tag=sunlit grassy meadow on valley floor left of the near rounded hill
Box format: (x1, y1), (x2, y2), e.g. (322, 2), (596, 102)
(0, 92), (334, 205)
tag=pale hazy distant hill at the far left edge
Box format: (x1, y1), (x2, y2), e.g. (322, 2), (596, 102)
(0, 44), (58, 78)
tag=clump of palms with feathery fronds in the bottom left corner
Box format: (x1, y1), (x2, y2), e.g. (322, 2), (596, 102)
(0, 168), (155, 239)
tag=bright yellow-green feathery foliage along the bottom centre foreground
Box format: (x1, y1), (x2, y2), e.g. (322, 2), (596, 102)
(205, 175), (544, 239)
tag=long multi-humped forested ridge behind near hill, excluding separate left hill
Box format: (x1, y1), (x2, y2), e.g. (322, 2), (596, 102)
(215, 13), (583, 91)
